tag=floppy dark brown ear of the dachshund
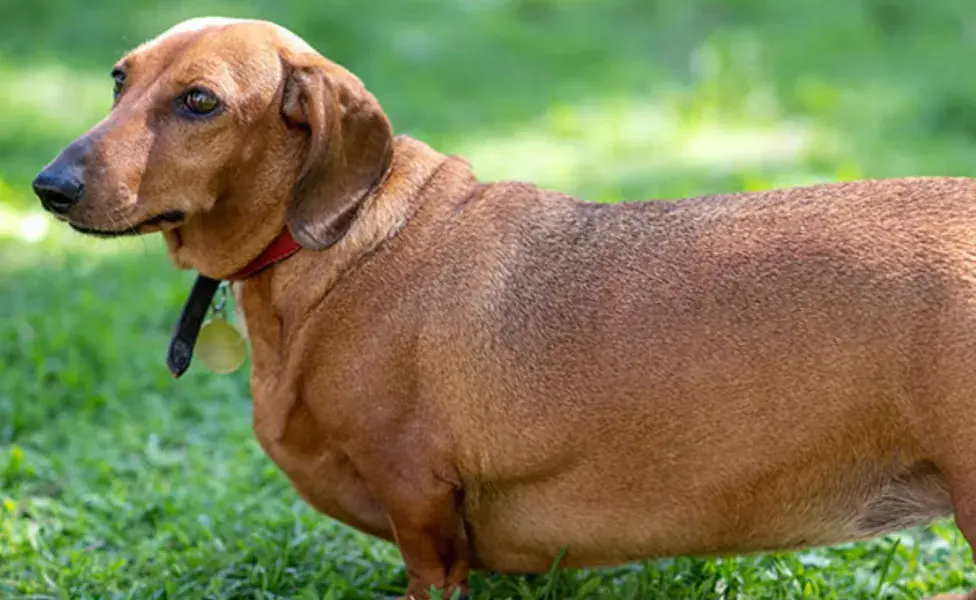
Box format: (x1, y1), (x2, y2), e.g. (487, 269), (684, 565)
(281, 59), (393, 250)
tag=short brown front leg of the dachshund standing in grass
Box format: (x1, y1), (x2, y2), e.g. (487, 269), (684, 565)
(357, 446), (471, 600)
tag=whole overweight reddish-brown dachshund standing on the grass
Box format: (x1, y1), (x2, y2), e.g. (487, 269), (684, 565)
(35, 19), (976, 598)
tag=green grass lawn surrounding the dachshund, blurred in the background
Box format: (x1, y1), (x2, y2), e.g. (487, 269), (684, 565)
(0, 0), (976, 600)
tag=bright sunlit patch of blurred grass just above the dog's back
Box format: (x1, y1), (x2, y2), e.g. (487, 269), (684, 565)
(454, 96), (816, 199)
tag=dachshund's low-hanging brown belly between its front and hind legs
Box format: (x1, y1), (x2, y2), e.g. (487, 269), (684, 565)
(467, 454), (951, 572)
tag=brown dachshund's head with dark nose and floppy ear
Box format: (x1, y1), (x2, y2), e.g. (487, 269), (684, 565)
(33, 19), (392, 276)
